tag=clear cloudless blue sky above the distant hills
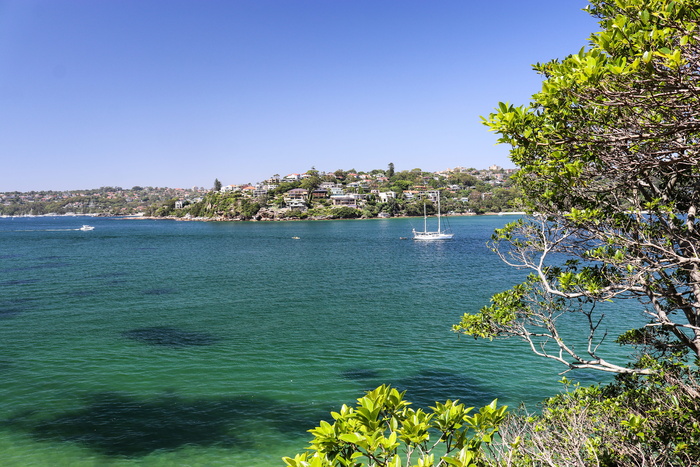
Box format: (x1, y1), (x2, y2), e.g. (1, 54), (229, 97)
(0, 0), (598, 191)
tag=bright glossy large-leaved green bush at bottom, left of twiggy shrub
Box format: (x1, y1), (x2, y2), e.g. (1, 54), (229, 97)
(284, 385), (506, 467)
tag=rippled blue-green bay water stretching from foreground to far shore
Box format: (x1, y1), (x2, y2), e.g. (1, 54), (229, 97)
(0, 216), (624, 466)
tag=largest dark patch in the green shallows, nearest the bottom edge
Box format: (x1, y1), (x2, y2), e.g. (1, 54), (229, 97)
(8, 393), (326, 457)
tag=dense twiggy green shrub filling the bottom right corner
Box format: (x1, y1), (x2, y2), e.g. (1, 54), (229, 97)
(497, 362), (700, 467)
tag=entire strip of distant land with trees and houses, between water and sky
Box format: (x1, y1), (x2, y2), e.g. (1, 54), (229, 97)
(0, 164), (519, 221)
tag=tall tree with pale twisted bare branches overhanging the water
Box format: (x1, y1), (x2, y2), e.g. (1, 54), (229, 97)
(455, 0), (700, 374)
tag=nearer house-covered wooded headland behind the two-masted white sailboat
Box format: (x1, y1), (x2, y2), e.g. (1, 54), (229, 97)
(146, 164), (517, 220)
